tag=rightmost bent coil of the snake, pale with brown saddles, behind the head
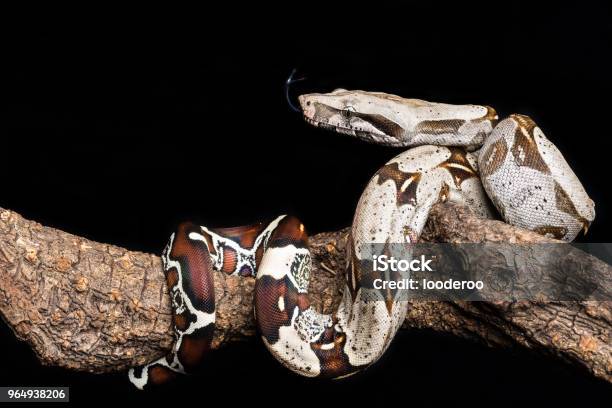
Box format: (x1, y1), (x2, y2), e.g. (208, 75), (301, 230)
(479, 115), (595, 241)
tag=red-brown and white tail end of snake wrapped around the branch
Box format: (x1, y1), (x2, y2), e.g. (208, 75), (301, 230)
(128, 215), (285, 389)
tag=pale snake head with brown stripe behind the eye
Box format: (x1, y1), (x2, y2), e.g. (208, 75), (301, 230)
(299, 89), (405, 146)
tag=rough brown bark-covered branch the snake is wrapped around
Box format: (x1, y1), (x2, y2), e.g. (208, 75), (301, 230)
(0, 204), (612, 381)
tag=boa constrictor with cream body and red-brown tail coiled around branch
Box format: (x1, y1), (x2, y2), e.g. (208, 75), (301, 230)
(129, 89), (595, 388)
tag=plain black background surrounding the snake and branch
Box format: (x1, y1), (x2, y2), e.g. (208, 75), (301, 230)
(0, 2), (612, 405)
